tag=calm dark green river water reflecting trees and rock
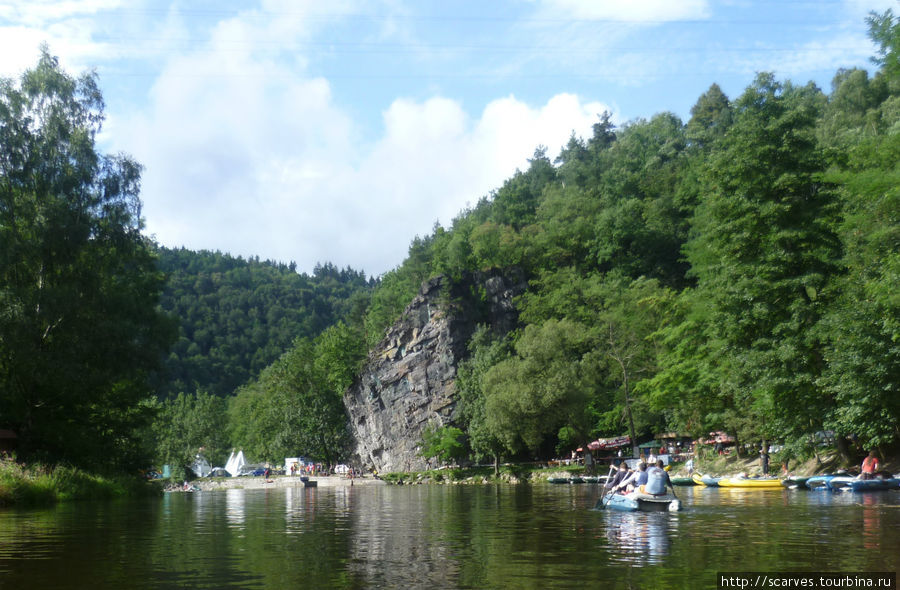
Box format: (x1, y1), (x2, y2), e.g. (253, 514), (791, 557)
(0, 484), (900, 590)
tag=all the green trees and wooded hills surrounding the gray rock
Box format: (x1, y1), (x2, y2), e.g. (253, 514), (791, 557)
(0, 11), (900, 478)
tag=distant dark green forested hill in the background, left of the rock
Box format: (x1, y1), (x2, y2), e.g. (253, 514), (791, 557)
(157, 247), (375, 397)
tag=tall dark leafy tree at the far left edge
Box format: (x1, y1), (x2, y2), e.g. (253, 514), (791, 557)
(0, 49), (171, 468)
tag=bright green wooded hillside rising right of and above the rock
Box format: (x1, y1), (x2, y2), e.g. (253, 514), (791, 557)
(358, 11), (900, 456)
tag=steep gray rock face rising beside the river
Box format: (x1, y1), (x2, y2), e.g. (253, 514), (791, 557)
(344, 272), (526, 472)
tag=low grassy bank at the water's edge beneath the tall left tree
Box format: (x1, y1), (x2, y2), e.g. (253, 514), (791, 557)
(0, 458), (154, 506)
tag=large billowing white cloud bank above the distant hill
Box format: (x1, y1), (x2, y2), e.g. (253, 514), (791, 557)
(128, 60), (608, 274)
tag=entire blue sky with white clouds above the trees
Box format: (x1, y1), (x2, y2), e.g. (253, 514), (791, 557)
(0, 0), (900, 275)
